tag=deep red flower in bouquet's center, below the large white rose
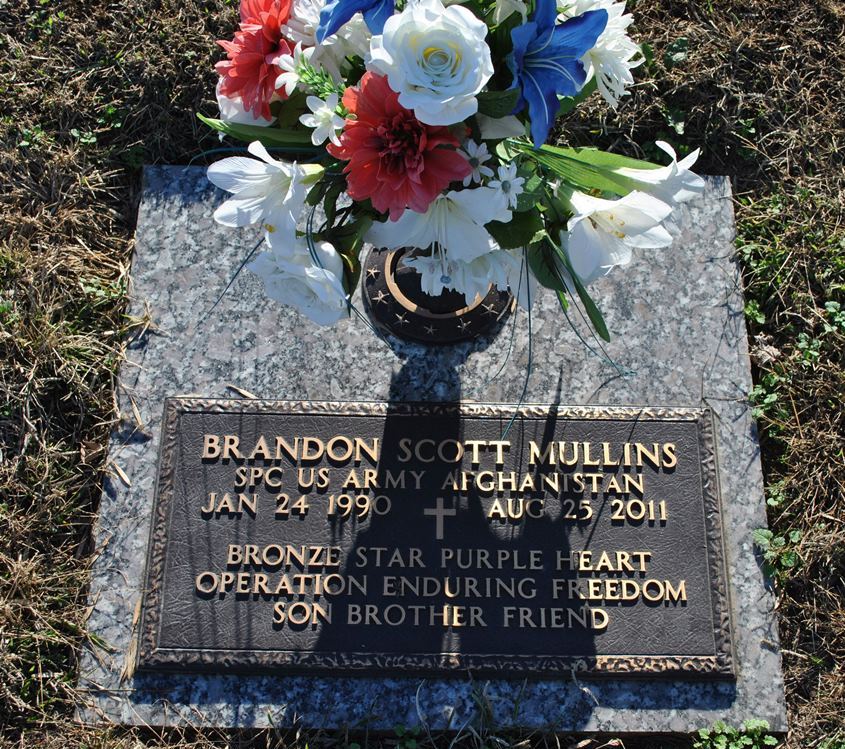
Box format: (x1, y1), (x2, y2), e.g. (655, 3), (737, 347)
(326, 73), (472, 221)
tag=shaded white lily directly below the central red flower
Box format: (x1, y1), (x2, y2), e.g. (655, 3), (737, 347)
(368, 187), (502, 262)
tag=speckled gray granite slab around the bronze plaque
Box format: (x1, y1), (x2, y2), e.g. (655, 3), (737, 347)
(79, 167), (786, 733)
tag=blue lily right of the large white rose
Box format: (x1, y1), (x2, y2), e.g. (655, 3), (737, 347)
(508, 0), (607, 148)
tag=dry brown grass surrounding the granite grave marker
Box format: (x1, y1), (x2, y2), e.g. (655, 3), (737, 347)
(0, 0), (845, 749)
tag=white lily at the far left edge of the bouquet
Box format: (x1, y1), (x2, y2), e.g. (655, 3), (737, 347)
(208, 141), (324, 233)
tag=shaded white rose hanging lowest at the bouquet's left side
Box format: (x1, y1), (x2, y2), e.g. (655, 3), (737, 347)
(247, 237), (348, 325)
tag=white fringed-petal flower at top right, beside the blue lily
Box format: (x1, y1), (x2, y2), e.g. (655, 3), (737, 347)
(558, 0), (645, 109)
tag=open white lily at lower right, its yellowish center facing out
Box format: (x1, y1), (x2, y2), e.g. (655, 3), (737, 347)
(561, 191), (672, 284)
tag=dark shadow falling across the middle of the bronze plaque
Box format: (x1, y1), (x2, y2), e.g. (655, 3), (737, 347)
(315, 354), (596, 730)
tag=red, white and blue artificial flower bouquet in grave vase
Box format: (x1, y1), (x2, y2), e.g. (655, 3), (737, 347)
(206, 0), (703, 339)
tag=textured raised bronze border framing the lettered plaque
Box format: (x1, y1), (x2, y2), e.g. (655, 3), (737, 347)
(138, 396), (735, 679)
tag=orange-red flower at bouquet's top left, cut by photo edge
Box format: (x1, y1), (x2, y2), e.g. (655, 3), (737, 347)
(214, 0), (293, 119)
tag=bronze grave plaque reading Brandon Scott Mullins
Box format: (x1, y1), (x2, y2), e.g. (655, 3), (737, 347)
(139, 398), (733, 678)
